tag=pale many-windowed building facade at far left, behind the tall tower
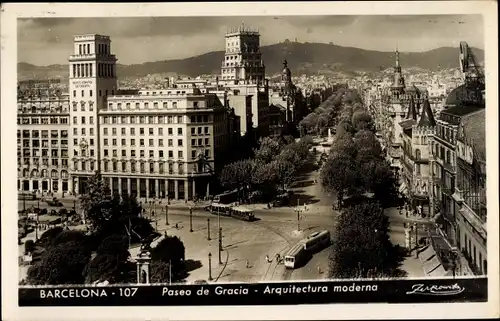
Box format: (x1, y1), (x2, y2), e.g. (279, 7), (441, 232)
(17, 84), (71, 193)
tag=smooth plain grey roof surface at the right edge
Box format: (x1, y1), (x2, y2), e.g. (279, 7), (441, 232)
(462, 108), (486, 161)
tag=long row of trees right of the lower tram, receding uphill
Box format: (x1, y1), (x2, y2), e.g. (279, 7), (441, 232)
(321, 90), (404, 278)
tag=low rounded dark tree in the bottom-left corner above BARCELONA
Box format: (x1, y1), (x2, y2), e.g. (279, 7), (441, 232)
(27, 242), (91, 285)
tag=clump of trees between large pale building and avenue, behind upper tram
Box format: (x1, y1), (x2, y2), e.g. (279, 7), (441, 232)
(219, 136), (312, 200)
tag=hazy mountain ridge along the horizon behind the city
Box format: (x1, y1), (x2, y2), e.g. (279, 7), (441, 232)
(18, 42), (484, 79)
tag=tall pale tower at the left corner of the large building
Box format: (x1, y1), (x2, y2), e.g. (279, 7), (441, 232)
(68, 34), (117, 194)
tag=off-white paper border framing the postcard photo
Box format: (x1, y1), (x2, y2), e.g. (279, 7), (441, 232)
(0, 1), (499, 320)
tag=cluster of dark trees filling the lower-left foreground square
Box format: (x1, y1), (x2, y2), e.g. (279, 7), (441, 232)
(25, 174), (185, 285)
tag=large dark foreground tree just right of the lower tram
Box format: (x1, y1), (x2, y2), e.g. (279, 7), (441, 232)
(329, 203), (404, 278)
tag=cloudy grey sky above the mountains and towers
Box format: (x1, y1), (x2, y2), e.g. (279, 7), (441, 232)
(18, 15), (484, 66)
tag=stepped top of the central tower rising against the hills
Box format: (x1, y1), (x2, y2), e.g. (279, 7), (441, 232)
(221, 24), (265, 84)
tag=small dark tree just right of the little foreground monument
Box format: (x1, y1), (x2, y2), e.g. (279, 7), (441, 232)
(151, 236), (186, 280)
